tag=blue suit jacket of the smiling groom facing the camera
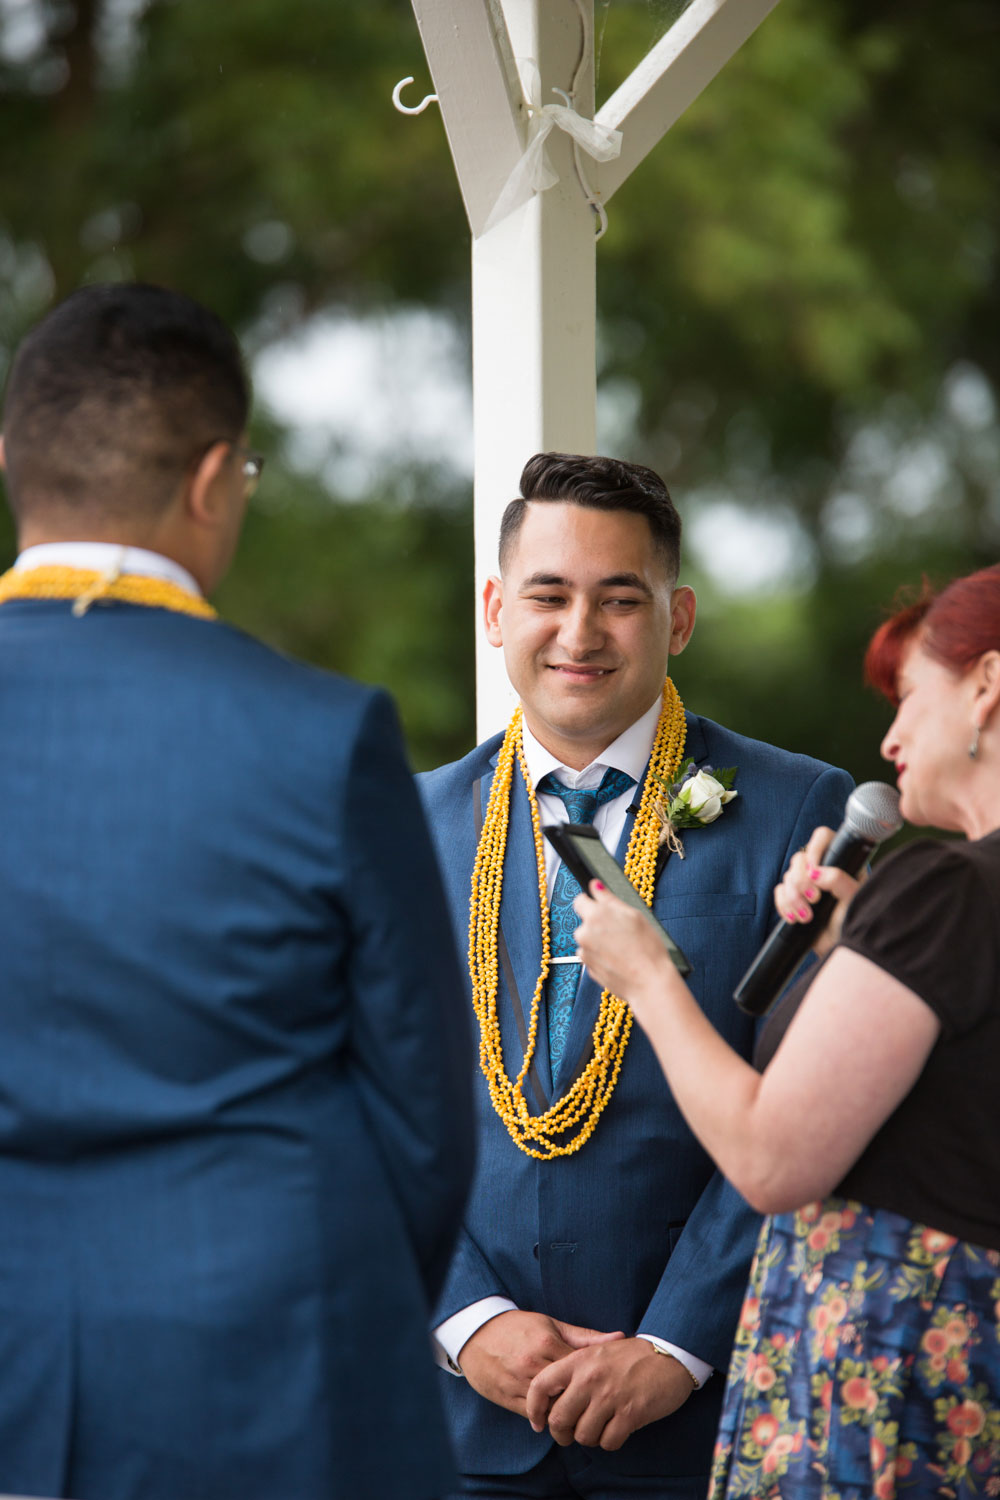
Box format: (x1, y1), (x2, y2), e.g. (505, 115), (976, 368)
(418, 716), (852, 1476)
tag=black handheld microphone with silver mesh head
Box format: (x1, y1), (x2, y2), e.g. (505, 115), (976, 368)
(733, 782), (903, 1016)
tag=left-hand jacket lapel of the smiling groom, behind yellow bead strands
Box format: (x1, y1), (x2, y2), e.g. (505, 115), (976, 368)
(475, 767), (552, 1113)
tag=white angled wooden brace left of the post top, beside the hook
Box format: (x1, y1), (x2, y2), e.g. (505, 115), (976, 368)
(412, 0), (526, 234)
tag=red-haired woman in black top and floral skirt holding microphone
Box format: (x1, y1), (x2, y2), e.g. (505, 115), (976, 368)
(566, 566), (1000, 1500)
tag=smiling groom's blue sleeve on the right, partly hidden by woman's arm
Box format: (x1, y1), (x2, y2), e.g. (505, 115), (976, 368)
(639, 768), (853, 1371)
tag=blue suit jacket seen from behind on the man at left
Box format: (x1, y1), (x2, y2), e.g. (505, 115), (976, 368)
(0, 602), (472, 1500)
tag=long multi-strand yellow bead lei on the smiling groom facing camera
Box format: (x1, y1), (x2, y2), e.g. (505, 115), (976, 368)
(469, 678), (687, 1161)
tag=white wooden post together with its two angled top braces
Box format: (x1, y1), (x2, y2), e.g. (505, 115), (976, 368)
(412, 0), (777, 740)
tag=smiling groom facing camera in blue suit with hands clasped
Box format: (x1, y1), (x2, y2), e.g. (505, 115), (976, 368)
(420, 453), (852, 1500)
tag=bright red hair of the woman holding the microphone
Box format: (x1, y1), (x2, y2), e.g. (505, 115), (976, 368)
(865, 564), (1000, 704)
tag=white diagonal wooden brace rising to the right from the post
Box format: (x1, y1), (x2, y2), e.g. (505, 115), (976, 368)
(594, 0), (778, 203)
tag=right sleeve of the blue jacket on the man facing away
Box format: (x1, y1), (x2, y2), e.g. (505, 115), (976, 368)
(342, 692), (475, 1304)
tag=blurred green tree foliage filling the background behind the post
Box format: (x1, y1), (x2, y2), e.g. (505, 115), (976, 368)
(0, 0), (1000, 776)
